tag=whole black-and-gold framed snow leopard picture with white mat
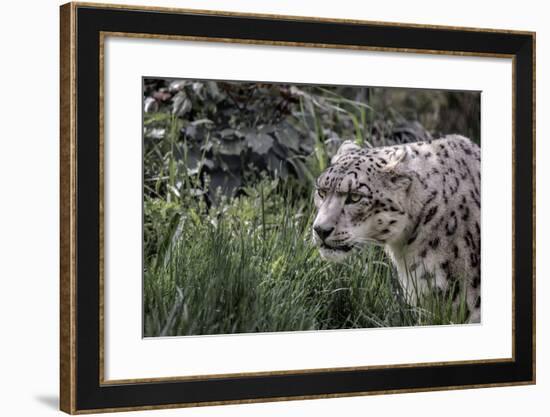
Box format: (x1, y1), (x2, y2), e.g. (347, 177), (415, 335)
(60, 3), (535, 414)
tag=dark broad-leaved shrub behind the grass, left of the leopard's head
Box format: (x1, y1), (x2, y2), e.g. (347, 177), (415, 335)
(144, 80), (326, 202)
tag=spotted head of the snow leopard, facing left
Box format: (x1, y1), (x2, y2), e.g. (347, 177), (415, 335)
(313, 141), (412, 261)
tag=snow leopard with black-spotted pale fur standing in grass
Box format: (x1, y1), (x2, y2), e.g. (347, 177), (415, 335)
(313, 135), (481, 323)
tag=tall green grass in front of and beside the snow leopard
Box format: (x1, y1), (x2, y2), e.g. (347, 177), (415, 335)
(144, 180), (465, 336)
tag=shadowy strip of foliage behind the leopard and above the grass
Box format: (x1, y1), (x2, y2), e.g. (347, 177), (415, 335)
(144, 79), (480, 205)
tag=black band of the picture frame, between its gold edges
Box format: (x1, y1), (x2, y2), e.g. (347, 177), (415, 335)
(76, 6), (534, 410)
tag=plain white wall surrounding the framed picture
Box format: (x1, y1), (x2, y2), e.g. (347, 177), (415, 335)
(0, 0), (550, 417)
